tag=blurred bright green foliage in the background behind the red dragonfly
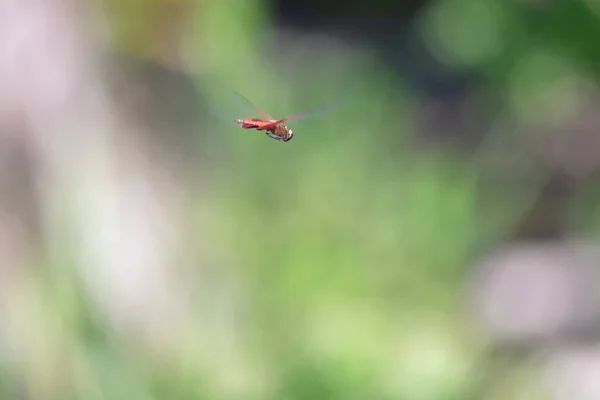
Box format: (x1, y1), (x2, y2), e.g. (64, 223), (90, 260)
(9, 0), (600, 400)
